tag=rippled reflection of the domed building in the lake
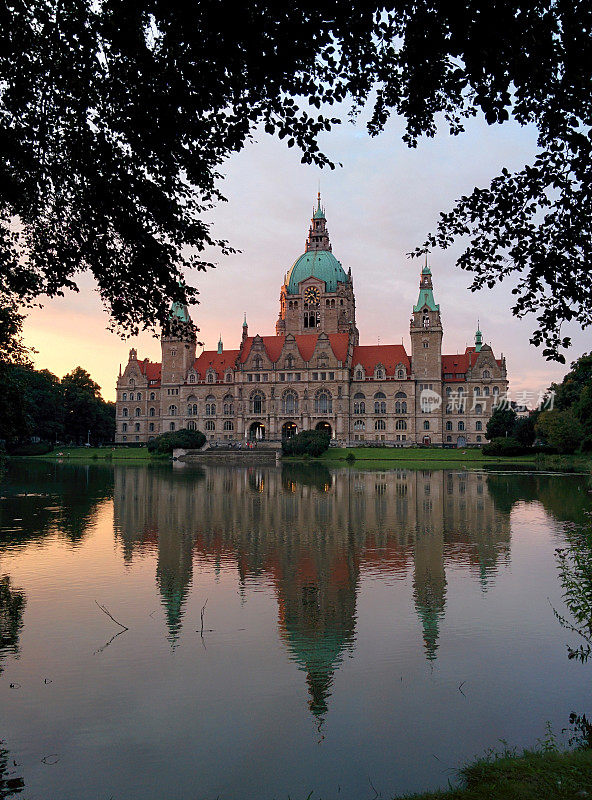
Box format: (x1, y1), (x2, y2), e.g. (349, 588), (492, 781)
(114, 465), (510, 719)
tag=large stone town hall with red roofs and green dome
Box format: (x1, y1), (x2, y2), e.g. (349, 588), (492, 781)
(116, 196), (508, 447)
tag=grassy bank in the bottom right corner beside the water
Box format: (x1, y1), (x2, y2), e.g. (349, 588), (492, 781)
(399, 750), (592, 800)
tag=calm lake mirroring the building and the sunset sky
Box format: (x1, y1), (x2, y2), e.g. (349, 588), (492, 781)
(0, 461), (592, 800)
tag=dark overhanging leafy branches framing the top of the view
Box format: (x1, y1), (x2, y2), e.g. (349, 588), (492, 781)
(0, 0), (592, 360)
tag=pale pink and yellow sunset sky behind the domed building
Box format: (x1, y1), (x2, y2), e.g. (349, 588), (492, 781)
(20, 109), (592, 400)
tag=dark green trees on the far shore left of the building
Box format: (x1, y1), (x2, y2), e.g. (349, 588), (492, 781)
(0, 362), (115, 452)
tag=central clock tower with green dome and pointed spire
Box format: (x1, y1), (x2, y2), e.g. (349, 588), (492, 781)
(276, 198), (358, 344)
